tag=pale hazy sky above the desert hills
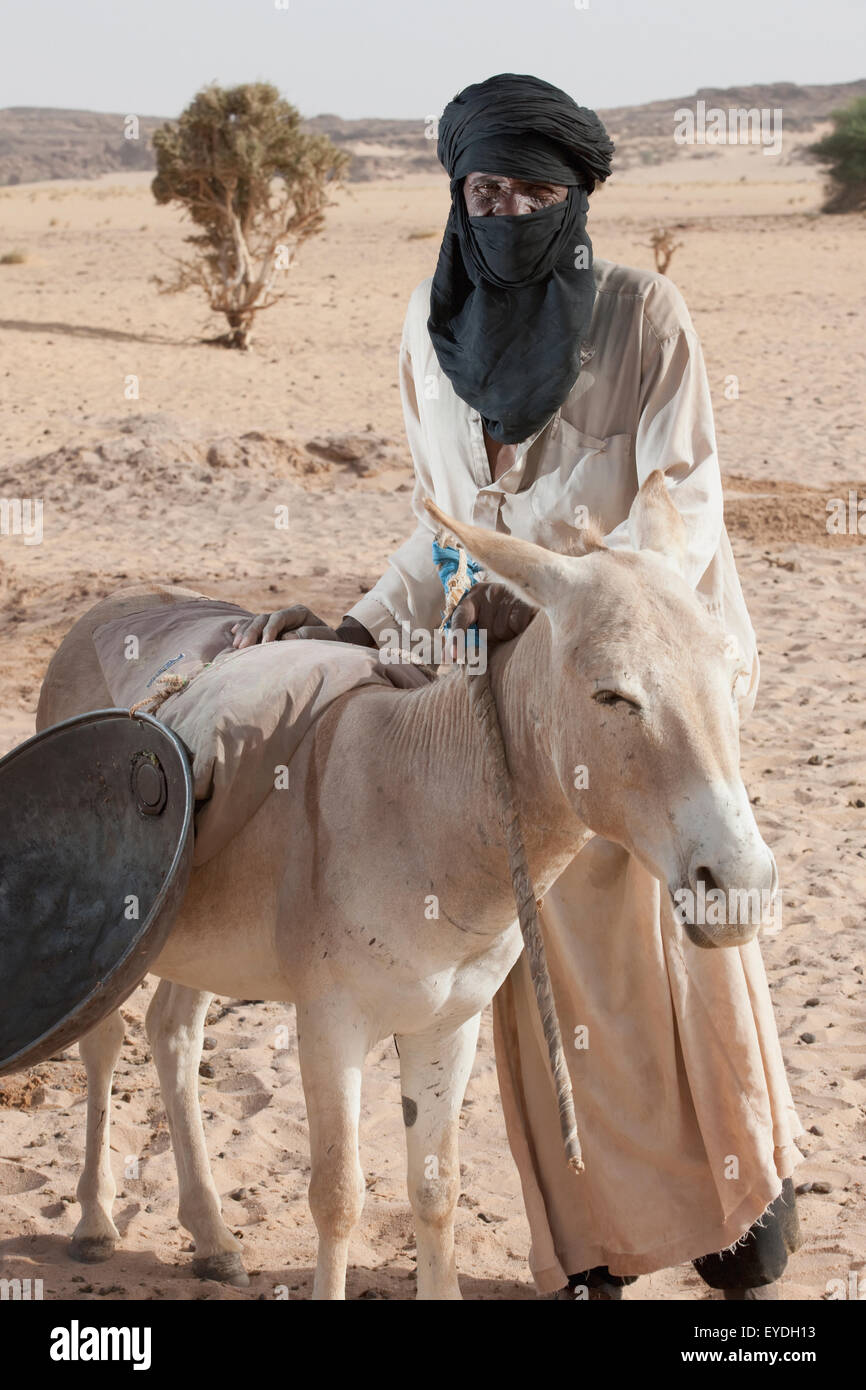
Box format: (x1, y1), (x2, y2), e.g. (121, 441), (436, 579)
(0, 0), (866, 117)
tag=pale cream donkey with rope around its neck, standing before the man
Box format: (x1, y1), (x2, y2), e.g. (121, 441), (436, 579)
(39, 473), (776, 1298)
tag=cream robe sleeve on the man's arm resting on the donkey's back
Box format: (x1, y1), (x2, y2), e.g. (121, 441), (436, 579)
(349, 332), (445, 641)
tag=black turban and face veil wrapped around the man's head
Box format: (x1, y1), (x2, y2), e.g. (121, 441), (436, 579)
(427, 74), (613, 443)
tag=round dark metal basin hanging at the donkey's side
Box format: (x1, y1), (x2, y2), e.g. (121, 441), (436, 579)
(0, 709), (195, 1074)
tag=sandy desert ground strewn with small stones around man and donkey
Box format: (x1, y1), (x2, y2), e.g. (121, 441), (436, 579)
(0, 150), (866, 1300)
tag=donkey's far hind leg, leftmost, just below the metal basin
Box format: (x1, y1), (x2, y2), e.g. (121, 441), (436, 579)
(70, 1009), (124, 1264)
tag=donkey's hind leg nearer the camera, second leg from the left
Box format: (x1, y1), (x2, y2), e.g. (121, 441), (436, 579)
(145, 980), (249, 1284)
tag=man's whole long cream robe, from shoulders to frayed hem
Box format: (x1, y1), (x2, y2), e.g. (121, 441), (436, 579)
(352, 260), (802, 1291)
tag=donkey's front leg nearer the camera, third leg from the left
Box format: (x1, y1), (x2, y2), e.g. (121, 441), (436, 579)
(297, 999), (368, 1298)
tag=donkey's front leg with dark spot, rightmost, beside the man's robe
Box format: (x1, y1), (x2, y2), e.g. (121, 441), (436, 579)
(398, 1015), (480, 1300)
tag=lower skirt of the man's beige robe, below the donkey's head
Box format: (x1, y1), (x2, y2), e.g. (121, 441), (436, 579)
(493, 838), (801, 1293)
